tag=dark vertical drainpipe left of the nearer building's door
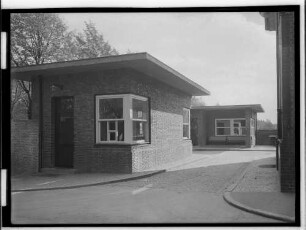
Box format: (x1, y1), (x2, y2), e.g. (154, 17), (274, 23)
(38, 75), (43, 172)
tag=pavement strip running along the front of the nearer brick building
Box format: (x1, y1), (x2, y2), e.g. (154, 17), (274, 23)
(11, 154), (207, 192)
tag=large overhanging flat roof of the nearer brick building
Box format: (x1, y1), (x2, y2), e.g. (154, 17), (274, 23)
(11, 52), (210, 96)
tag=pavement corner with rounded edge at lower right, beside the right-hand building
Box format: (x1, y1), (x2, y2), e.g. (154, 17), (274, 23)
(223, 157), (296, 222)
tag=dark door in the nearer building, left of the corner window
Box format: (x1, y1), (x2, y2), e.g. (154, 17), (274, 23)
(53, 97), (74, 168)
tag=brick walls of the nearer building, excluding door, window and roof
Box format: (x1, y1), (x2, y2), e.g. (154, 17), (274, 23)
(33, 69), (191, 172)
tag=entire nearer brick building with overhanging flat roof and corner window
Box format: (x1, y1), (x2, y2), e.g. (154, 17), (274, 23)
(12, 53), (209, 173)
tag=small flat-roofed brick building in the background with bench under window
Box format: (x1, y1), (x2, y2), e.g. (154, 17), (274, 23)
(191, 105), (264, 147)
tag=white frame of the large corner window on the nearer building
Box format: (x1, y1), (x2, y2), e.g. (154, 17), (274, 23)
(95, 94), (150, 144)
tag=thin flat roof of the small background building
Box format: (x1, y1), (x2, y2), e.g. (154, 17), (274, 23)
(191, 104), (264, 113)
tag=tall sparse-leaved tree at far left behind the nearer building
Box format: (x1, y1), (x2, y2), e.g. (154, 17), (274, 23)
(11, 13), (67, 119)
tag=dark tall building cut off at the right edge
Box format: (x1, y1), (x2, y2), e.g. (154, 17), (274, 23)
(261, 11), (300, 192)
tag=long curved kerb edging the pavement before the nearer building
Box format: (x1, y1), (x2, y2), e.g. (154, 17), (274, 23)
(11, 169), (167, 192)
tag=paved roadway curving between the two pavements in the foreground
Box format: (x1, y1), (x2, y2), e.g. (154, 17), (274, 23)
(12, 150), (279, 224)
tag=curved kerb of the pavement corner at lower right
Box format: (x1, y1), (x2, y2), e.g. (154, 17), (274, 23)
(223, 192), (295, 223)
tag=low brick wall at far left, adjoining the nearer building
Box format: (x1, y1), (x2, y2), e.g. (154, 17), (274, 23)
(11, 120), (38, 175)
